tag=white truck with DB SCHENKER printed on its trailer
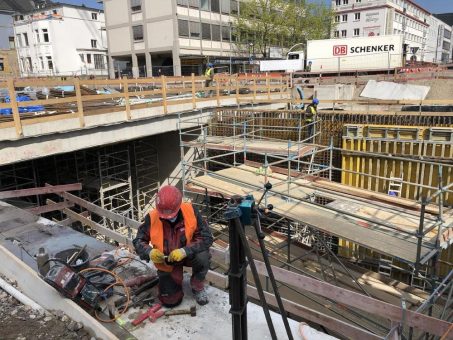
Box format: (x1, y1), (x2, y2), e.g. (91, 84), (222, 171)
(260, 35), (403, 73)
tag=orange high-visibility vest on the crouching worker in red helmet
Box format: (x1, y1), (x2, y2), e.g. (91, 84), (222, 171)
(149, 203), (197, 272)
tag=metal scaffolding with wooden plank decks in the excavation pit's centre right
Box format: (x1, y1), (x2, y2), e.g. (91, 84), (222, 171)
(180, 111), (453, 286)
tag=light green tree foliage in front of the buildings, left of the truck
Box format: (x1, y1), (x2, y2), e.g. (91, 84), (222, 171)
(233, 0), (334, 58)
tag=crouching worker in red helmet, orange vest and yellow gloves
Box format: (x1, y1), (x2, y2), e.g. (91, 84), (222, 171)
(133, 185), (213, 307)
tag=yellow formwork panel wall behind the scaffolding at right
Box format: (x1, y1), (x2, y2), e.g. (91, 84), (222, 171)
(339, 124), (453, 275)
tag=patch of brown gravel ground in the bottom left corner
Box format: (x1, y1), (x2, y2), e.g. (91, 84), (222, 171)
(0, 278), (96, 340)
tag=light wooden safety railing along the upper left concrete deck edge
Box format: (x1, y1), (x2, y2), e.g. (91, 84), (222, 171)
(0, 74), (289, 137)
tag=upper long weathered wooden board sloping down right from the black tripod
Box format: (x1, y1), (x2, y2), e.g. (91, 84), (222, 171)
(255, 260), (451, 336)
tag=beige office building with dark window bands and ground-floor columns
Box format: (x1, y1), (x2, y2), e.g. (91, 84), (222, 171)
(103, 0), (244, 78)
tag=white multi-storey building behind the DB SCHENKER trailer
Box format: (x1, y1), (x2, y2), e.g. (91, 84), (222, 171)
(332, 0), (451, 63)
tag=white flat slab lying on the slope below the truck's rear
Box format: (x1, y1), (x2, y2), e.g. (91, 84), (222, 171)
(360, 80), (430, 100)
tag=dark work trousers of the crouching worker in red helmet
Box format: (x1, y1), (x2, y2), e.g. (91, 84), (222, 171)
(157, 250), (211, 307)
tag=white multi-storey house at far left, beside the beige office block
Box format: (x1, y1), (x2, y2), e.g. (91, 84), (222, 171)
(14, 4), (108, 77)
